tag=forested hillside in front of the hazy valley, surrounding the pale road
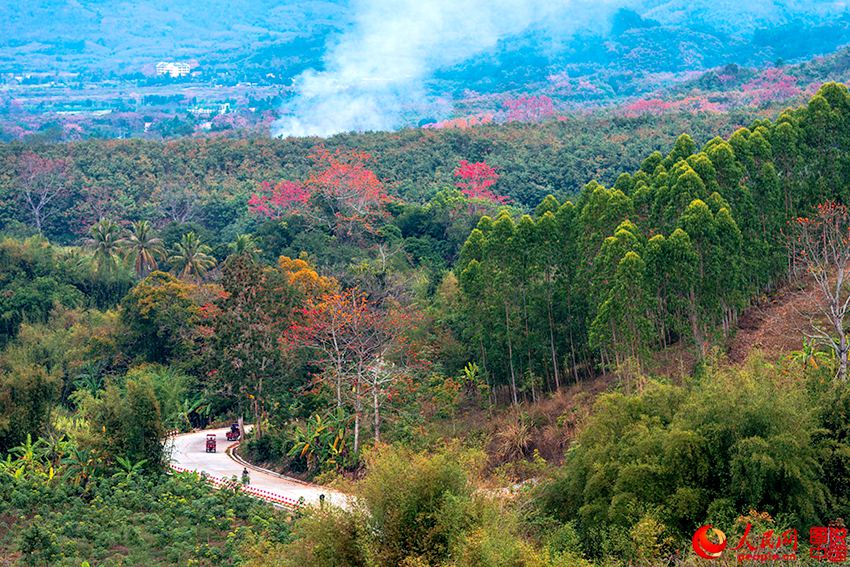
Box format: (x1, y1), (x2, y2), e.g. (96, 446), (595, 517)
(0, 64), (850, 567)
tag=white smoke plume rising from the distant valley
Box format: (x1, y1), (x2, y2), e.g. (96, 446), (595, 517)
(272, 0), (608, 136)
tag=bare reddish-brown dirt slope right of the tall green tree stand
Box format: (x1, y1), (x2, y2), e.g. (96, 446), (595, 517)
(729, 282), (820, 364)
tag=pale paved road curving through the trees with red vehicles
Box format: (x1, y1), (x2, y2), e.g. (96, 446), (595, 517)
(171, 427), (347, 507)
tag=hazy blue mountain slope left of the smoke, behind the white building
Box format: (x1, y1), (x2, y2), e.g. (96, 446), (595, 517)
(0, 0), (345, 75)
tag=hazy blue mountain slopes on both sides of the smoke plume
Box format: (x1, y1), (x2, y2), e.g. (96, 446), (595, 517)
(6, 0), (847, 74)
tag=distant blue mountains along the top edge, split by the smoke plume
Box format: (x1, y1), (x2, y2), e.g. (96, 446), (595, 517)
(6, 0), (850, 81)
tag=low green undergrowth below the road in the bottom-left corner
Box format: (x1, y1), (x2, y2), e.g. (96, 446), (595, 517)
(0, 465), (290, 567)
